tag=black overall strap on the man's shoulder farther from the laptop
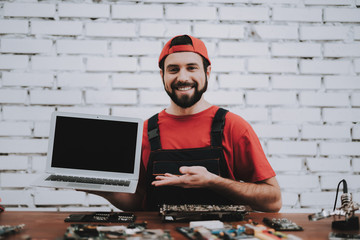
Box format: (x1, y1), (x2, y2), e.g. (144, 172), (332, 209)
(211, 108), (228, 147)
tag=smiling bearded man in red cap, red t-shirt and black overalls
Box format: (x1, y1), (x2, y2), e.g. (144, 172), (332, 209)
(92, 35), (282, 212)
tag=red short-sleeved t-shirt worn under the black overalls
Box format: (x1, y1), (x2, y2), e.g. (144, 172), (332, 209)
(142, 106), (275, 182)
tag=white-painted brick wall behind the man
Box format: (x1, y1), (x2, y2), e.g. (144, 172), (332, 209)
(0, 0), (360, 212)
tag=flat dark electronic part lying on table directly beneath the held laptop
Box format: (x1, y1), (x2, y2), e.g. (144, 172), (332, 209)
(64, 212), (136, 223)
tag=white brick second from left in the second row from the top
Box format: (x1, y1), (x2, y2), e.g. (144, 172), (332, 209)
(30, 20), (82, 36)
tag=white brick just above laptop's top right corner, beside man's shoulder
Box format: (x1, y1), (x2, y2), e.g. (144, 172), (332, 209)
(111, 106), (164, 120)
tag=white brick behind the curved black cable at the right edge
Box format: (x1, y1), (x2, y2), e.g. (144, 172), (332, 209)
(321, 174), (360, 190)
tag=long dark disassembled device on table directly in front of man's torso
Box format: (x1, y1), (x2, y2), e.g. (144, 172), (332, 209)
(160, 204), (251, 222)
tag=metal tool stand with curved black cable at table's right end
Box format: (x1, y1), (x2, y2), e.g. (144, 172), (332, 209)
(308, 179), (360, 230)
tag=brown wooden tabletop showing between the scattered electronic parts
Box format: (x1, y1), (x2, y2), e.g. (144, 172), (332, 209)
(0, 211), (359, 240)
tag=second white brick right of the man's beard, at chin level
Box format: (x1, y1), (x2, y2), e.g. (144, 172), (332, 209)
(246, 91), (297, 105)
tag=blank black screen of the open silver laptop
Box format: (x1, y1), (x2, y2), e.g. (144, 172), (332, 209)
(51, 116), (138, 174)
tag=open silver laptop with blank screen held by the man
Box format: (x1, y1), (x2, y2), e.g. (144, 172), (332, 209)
(32, 112), (143, 193)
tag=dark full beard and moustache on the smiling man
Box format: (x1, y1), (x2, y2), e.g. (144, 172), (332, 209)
(163, 76), (208, 108)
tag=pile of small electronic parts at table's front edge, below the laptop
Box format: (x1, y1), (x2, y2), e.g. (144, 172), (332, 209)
(64, 223), (172, 240)
